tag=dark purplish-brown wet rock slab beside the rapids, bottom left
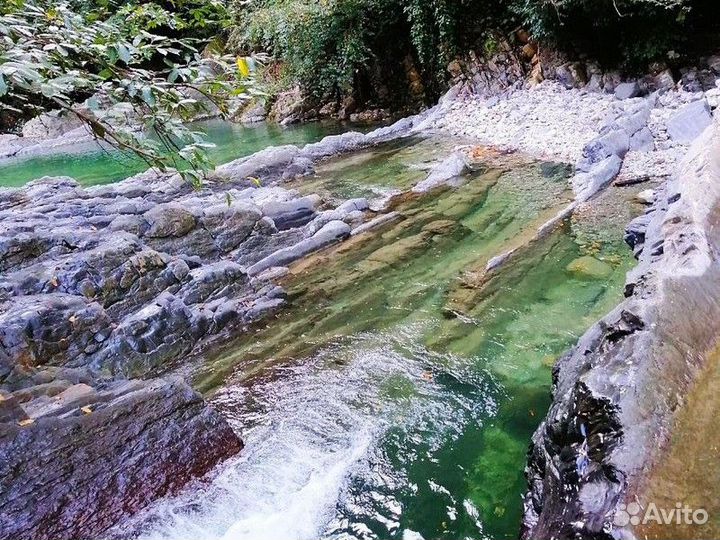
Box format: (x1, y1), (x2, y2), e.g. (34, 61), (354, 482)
(0, 380), (242, 540)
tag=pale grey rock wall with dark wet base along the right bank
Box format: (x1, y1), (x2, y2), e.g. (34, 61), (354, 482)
(522, 123), (720, 539)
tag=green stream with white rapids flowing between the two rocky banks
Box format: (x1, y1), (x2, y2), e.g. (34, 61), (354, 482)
(112, 141), (631, 540)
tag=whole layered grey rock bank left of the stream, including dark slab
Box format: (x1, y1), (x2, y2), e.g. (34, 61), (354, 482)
(0, 110), (438, 540)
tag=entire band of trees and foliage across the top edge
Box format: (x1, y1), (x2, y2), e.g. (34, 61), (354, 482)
(0, 0), (717, 175)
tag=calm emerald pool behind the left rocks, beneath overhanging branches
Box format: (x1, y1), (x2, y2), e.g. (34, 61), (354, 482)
(0, 120), (348, 187)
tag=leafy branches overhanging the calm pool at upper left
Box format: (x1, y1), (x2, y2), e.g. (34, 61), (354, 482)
(0, 0), (252, 183)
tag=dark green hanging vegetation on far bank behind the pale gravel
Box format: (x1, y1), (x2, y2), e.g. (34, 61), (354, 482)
(232, 0), (716, 106)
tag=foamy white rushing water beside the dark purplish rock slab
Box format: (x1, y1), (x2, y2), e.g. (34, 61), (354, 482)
(120, 327), (500, 540)
